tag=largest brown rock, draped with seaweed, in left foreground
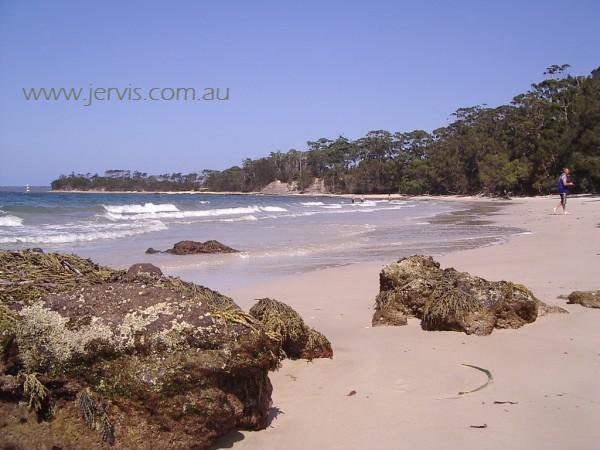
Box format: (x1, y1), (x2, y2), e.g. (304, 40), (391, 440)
(0, 251), (280, 449)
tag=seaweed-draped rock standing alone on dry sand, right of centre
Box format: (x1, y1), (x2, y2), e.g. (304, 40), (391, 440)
(373, 255), (550, 335)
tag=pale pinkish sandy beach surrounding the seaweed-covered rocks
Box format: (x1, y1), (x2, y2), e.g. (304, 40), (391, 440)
(206, 197), (600, 449)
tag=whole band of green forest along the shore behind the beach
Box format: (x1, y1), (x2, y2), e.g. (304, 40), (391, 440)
(52, 64), (600, 195)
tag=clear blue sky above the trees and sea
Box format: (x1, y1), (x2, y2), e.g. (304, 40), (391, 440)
(0, 0), (600, 185)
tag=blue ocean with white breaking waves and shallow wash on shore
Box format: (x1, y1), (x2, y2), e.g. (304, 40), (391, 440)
(0, 188), (523, 289)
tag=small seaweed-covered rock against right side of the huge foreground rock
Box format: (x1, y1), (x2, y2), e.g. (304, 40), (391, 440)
(250, 298), (333, 360)
